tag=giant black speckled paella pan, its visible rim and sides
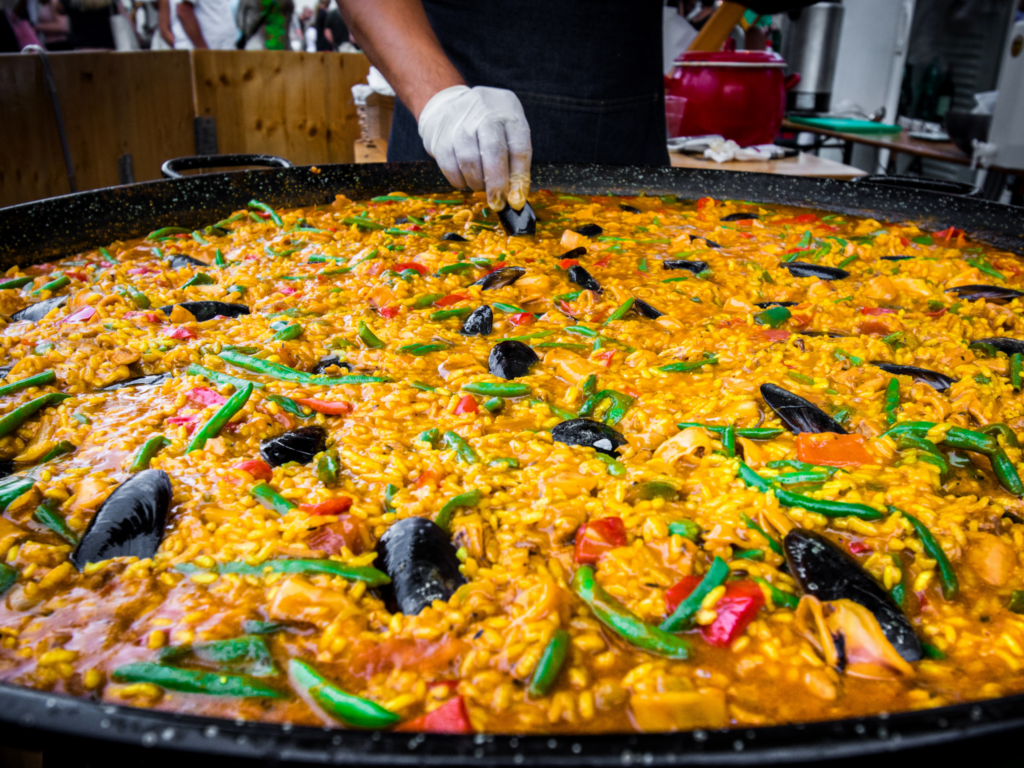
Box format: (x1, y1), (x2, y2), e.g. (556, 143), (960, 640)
(0, 159), (1024, 768)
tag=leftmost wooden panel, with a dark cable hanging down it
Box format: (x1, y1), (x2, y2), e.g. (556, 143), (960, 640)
(0, 51), (194, 206)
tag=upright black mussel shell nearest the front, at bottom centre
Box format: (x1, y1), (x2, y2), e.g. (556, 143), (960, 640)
(376, 517), (466, 616)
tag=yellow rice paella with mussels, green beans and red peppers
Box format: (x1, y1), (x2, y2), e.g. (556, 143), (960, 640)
(0, 190), (1024, 733)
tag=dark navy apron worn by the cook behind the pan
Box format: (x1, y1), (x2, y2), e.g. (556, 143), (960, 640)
(387, 0), (669, 166)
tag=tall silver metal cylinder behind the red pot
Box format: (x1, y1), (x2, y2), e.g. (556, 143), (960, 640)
(782, 2), (843, 114)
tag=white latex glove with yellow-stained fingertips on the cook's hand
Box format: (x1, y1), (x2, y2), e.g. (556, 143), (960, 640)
(420, 85), (534, 211)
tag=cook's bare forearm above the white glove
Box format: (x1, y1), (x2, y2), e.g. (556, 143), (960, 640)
(338, 0), (466, 120)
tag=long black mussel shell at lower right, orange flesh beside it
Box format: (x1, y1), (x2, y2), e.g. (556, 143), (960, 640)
(782, 528), (924, 662)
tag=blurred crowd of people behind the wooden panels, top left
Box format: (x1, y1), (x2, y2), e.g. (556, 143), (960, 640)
(0, 0), (358, 53)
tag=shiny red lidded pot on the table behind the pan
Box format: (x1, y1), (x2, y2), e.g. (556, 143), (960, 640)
(665, 50), (800, 146)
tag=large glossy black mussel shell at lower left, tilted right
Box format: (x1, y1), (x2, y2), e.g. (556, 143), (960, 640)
(71, 469), (172, 570)
